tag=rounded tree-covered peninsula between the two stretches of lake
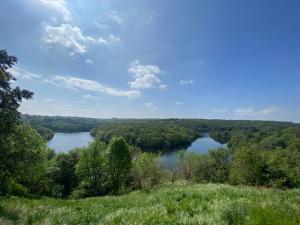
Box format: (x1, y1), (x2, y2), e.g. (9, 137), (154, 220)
(91, 121), (198, 151)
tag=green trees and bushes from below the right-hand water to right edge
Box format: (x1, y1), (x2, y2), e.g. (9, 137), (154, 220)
(180, 127), (300, 188)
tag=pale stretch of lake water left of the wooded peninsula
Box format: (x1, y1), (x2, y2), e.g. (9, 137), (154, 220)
(48, 132), (93, 152)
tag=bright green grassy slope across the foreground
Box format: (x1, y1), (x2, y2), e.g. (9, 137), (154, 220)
(0, 183), (300, 225)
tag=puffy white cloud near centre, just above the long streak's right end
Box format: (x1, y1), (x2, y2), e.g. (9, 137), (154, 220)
(128, 60), (167, 89)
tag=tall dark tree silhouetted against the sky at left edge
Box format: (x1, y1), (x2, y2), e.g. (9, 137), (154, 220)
(0, 50), (33, 195)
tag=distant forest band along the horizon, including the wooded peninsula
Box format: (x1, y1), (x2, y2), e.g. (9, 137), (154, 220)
(22, 115), (300, 145)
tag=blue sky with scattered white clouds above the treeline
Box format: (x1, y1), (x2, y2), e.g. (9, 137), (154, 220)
(0, 0), (300, 122)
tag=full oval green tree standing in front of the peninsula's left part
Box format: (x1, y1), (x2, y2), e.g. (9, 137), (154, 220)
(106, 137), (131, 194)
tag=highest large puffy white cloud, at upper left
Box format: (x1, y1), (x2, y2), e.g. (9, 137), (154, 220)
(43, 24), (108, 55)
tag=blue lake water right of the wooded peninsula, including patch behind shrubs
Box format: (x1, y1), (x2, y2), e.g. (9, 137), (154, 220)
(161, 134), (227, 168)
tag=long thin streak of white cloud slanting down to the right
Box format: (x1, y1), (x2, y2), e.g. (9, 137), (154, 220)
(44, 75), (141, 98)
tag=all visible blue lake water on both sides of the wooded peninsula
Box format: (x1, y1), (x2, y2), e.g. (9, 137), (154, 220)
(48, 132), (227, 168)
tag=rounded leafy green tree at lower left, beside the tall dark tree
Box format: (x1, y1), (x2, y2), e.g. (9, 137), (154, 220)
(1, 124), (49, 195)
